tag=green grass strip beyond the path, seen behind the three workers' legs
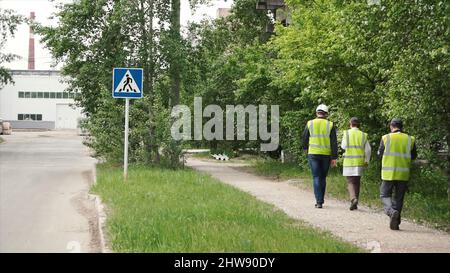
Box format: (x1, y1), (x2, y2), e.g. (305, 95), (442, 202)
(249, 160), (450, 232)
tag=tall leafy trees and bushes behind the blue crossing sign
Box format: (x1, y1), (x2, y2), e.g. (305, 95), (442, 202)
(36, 0), (190, 165)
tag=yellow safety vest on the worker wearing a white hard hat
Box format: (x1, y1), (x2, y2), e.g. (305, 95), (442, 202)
(307, 118), (333, 155)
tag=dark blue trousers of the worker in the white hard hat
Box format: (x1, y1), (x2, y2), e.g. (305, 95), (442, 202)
(308, 155), (331, 204)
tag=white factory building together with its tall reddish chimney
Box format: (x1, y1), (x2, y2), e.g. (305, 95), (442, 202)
(0, 12), (82, 130)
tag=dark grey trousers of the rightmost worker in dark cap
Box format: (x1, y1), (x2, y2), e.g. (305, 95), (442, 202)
(380, 181), (408, 216)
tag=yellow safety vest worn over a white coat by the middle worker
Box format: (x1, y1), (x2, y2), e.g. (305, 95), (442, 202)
(344, 129), (367, 167)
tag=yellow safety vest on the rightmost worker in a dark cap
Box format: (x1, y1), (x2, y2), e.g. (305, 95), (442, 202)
(381, 133), (415, 181)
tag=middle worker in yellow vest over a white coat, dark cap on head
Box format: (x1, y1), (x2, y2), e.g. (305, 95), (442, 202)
(341, 117), (372, 210)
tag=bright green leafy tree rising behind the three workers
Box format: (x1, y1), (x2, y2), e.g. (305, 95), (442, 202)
(250, 0), (450, 196)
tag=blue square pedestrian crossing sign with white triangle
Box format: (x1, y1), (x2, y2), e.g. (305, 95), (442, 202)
(113, 68), (144, 99)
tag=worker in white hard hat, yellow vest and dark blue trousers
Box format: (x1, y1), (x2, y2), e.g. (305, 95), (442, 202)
(303, 104), (337, 208)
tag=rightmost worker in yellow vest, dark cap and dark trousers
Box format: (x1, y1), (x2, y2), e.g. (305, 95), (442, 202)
(378, 118), (417, 230)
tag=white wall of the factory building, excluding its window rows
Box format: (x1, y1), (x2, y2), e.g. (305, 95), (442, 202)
(0, 70), (82, 129)
